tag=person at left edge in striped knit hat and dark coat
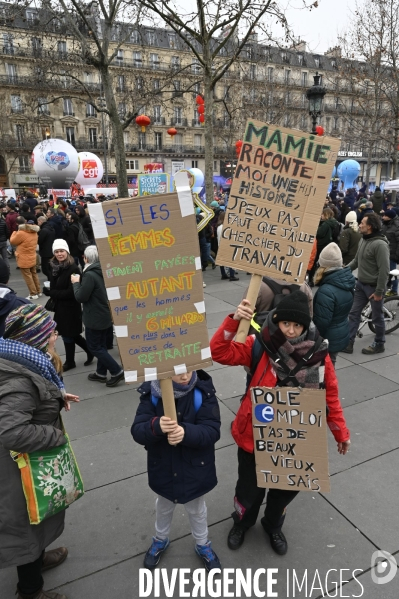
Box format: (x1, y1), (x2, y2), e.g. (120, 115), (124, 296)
(0, 304), (79, 599)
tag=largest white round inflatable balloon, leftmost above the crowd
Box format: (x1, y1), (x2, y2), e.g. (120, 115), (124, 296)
(32, 139), (79, 189)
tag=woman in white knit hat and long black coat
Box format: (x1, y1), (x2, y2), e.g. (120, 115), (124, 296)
(71, 245), (124, 387)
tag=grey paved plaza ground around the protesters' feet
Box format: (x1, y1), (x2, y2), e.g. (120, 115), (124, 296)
(0, 260), (399, 599)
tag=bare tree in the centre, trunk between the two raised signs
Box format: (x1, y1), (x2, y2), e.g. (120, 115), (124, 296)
(141, 0), (317, 204)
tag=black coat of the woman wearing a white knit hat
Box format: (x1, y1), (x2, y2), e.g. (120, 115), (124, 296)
(73, 262), (112, 331)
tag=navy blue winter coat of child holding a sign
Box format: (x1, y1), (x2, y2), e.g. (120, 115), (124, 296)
(131, 370), (220, 503)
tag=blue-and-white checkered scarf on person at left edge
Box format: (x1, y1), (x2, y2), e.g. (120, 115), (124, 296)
(0, 337), (65, 395)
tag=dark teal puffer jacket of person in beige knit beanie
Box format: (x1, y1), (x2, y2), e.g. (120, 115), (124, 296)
(313, 268), (356, 352)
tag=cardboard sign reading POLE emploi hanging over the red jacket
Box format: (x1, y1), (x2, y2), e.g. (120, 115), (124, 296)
(251, 387), (330, 493)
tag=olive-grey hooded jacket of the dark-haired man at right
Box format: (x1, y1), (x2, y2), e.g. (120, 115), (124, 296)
(348, 231), (389, 295)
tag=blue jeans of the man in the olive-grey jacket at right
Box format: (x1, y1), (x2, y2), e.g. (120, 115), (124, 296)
(349, 281), (385, 343)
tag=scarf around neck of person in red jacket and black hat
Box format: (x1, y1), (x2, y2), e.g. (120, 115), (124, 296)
(261, 310), (328, 389)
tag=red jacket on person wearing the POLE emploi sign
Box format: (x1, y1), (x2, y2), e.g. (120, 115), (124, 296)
(210, 315), (350, 453)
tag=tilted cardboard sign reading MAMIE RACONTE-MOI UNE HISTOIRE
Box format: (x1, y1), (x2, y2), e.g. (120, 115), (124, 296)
(217, 120), (341, 283)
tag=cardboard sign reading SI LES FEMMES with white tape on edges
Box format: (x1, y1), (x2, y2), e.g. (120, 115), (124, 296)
(87, 192), (212, 383)
